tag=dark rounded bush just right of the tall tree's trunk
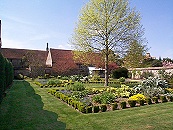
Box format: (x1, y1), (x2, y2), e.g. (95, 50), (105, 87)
(112, 67), (128, 79)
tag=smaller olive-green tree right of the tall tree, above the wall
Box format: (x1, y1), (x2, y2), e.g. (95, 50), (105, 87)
(124, 41), (148, 68)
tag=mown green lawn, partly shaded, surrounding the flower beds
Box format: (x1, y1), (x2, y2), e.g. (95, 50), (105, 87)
(0, 81), (173, 130)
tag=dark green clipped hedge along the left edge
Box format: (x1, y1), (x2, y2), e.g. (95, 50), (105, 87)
(0, 53), (14, 103)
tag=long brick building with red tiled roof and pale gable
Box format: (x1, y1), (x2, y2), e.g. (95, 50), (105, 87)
(1, 48), (93, 77)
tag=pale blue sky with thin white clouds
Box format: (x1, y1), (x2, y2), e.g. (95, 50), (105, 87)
(0, 0), (173, 59)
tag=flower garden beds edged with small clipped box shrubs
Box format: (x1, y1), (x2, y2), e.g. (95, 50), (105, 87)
(34, 76), (173, 113)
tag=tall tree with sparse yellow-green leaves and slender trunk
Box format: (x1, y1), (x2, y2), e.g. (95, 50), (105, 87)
(72, 0), (143, 86)
